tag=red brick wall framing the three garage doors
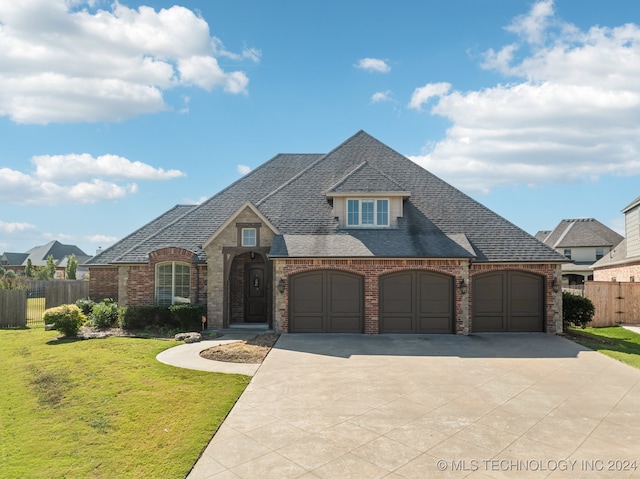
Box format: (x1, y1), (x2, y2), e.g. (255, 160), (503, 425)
(273, 259), (562, 334)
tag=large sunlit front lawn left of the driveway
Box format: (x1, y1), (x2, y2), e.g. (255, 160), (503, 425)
(0, 329), (249, 479)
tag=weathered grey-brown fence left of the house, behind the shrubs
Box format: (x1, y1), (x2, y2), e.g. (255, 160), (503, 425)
(0, 280), (89, 328)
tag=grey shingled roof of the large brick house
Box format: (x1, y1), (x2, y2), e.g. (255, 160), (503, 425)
(92, 131), (566, 265)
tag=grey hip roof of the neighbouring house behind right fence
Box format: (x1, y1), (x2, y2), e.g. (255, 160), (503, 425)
(536, 218), (623, 248)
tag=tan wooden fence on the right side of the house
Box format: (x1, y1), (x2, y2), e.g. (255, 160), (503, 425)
(584, 281), (640, 328)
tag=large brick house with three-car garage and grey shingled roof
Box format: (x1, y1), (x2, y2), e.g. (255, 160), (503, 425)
(88, 131), (566, 334)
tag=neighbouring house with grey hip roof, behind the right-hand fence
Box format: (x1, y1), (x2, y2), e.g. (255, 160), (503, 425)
(536, 218), (624, 286)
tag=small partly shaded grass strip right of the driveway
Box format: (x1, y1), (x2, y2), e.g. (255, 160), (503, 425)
(567, 326), (640, 369)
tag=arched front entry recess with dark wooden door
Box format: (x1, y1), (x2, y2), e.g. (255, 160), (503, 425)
(227, 252), (272, 325)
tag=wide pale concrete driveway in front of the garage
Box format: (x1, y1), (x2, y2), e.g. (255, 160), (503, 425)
(188, 333), (640, 479)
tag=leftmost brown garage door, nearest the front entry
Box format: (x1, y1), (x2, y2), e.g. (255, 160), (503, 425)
(289, 270), (364, 333)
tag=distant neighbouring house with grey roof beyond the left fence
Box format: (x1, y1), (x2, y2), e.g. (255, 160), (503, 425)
(0, 241), (91, 279)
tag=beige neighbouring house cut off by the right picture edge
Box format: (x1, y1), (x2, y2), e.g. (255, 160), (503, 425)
(593, 196), (640, 282)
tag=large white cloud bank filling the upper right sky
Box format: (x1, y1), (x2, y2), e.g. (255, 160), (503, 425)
(409, 0), (640, 192)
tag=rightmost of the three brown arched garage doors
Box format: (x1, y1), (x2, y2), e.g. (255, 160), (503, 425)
(472, 271), (544, 332)
